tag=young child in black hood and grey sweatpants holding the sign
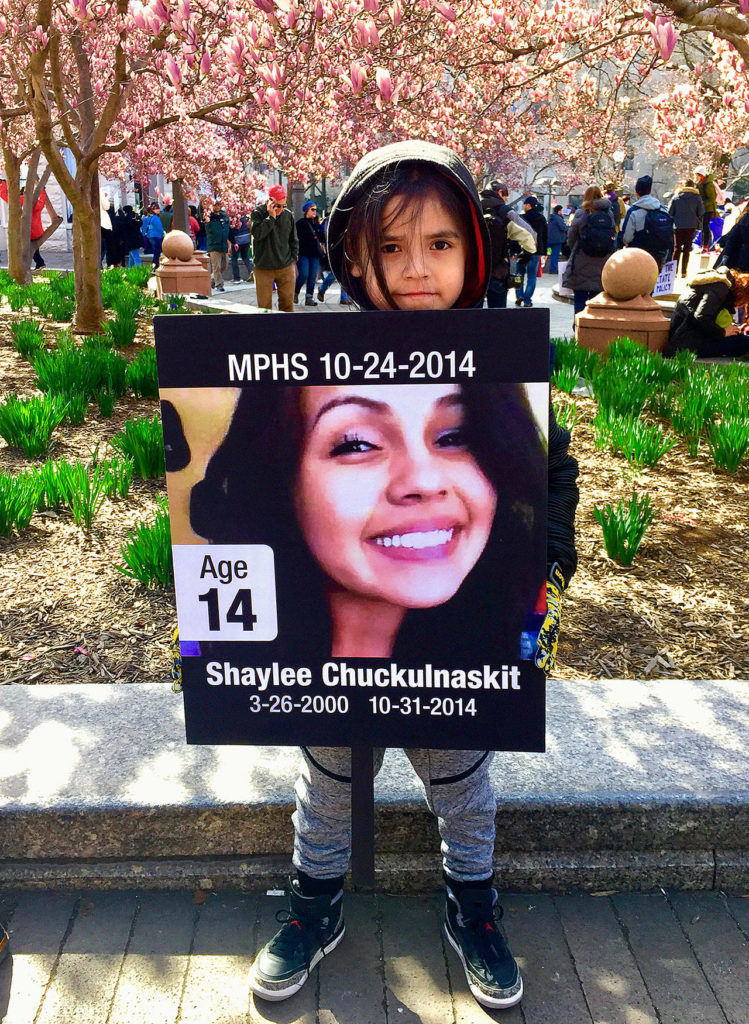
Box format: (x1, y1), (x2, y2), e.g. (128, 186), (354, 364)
(250, 141), (577, 1008)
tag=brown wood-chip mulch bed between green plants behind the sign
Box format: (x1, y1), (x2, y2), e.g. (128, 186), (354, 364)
(0, 314), (749, 683)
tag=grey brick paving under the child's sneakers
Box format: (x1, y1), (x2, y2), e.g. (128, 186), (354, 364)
(0, 892), (749, 1024)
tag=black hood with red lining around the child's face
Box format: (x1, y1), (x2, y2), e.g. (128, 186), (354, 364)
(328, 139), (492, 309)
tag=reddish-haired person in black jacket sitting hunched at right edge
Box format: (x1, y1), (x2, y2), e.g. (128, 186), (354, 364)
(663, 266), (749, 357)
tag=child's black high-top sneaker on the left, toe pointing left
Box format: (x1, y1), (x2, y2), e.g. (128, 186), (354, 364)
(250, 881), (345, 1002)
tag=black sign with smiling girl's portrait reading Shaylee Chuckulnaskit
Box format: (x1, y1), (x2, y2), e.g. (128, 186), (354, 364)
(155, 309), (548, 751)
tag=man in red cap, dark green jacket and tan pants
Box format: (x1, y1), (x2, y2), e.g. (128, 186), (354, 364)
(250, 185), (299, 313)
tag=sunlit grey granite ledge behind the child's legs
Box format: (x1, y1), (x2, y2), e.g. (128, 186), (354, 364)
(0, 680), (749, 892)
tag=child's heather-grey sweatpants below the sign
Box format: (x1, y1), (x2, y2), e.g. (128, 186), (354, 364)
(292, 746), (497, 882)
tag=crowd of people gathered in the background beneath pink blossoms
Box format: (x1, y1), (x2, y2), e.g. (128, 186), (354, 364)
(5, 156), (749, 354)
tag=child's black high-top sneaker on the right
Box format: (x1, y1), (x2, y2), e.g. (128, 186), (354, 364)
(445, 886), (523, 1009)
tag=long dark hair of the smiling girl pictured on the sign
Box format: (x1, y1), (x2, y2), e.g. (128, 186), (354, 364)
(190, 382), (546, 667)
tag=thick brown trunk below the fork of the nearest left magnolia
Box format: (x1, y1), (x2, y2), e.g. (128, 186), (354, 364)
(68, 173), (105, 334)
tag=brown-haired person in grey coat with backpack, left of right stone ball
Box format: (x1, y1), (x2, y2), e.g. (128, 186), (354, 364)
(561, 185), (617, 314)
